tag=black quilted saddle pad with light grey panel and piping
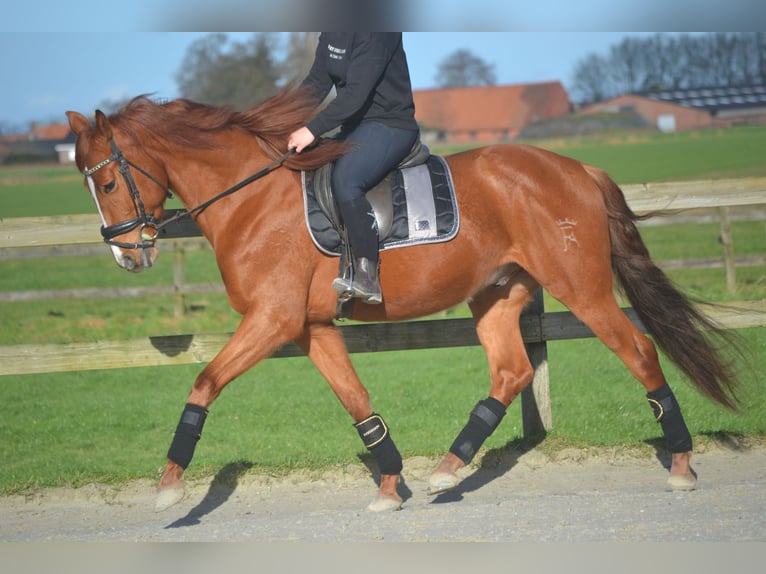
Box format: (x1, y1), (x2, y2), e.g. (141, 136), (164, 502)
(302, 155), (460, 256)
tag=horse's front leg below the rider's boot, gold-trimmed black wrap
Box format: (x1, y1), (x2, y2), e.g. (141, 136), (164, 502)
(295, 323), (402, 512)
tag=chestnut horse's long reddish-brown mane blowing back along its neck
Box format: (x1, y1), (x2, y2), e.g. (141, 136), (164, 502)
(109, 86), (346, 170)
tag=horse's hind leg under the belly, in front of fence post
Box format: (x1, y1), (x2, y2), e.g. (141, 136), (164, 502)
(429, 270), (538, 494)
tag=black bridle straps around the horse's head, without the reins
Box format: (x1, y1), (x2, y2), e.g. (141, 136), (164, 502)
(84, 140), (173, 249)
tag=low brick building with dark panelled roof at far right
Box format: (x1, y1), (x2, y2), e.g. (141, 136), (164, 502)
(579, 85), (766, 132)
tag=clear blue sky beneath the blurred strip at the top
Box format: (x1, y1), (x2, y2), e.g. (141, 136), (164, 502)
(0, 32), (664, 126)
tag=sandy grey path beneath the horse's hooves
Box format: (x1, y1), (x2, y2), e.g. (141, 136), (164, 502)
(0, 443), (766, 542)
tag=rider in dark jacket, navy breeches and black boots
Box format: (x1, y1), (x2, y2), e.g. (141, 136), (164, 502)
(287, 32), (420, 304)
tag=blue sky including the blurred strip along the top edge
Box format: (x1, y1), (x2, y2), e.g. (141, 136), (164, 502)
(0, 0), (766, 129)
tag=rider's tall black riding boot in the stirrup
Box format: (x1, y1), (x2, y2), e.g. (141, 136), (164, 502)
(332, 197), (383, 305)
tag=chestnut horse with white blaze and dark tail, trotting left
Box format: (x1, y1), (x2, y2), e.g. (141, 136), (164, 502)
(67, 89), (736, 510)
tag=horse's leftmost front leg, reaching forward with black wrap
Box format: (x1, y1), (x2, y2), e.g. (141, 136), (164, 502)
(155, 311), (302, 512)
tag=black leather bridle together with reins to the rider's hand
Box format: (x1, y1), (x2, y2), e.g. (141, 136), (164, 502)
(84, 140), (295, 249)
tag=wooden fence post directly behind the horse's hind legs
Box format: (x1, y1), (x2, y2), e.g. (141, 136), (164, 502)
(521, 289), (553, 438)
